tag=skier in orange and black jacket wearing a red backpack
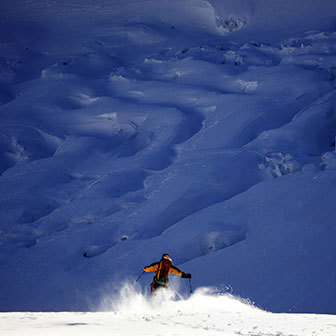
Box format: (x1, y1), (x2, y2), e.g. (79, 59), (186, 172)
(143, 253), (191, 293)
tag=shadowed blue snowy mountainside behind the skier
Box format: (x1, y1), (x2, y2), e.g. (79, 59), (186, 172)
(0, 0), (336, 313)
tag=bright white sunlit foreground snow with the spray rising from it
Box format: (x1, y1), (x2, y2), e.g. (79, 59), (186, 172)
(0, 288), (336, 336)
